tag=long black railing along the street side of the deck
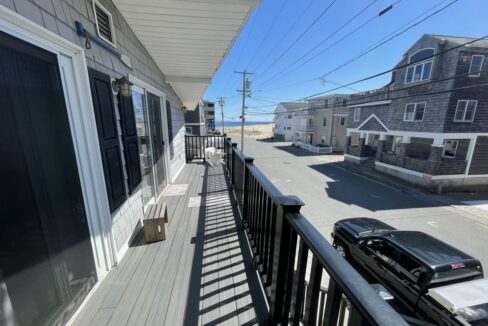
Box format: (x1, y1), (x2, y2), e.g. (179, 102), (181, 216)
(187, 136), (407, 325)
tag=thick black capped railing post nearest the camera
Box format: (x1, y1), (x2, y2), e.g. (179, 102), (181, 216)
(269, 196), (304, 325)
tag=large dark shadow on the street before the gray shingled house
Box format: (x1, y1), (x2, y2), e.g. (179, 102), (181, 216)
(309, 162), (445, 211)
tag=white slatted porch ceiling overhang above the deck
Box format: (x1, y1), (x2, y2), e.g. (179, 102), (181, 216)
(114, 0), (260, 110)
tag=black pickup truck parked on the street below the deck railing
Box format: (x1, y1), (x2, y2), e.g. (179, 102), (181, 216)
(332, 217), (484, 325)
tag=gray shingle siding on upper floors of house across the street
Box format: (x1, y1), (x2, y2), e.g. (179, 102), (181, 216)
(348, 35), (488, 133)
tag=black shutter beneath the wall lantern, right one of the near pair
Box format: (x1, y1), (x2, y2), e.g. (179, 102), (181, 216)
(119, 93), (141, 193)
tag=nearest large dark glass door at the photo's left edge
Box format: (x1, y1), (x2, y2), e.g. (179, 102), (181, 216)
(0, 32), (96, 326)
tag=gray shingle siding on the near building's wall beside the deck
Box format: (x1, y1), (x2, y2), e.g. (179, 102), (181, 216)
(0, 0), (185, 250)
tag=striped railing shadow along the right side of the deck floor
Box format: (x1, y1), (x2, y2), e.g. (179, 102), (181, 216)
(184, 166), (266, 326)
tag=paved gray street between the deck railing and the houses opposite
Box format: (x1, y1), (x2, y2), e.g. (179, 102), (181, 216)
(233, 137), (488, 270)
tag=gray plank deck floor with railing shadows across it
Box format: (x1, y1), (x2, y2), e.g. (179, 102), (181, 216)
(73, 163), (266, 326)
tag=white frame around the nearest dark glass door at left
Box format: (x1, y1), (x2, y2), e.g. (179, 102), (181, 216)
(0, 5), (116, 280)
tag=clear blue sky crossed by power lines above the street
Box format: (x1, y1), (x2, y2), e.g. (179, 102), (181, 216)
(204, 0), (488, 121)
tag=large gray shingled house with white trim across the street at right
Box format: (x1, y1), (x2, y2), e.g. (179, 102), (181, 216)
(345, 34), (488, 191)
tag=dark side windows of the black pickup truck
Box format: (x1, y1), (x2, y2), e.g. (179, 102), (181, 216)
(366, 239), (422, 281)
